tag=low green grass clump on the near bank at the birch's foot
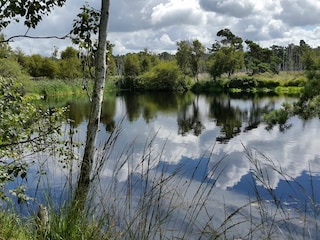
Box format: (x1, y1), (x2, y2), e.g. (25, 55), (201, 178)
(0, 204), (110, 240)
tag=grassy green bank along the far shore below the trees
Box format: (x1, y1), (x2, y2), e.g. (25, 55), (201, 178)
(18, 72), (306, 97)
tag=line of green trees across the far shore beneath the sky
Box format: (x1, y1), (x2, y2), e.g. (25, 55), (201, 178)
(0, 28), (320, 86)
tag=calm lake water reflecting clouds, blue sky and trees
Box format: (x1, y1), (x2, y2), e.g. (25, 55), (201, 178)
(7, 93), (320, 239)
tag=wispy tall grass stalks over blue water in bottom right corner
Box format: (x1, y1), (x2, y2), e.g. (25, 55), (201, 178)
(245, 145), (320, 239)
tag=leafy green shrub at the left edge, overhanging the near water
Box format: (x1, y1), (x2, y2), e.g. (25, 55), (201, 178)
(0, 77), (65, 203)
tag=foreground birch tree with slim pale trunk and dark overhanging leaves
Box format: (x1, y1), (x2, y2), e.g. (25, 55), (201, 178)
(0, 0), (110, 211)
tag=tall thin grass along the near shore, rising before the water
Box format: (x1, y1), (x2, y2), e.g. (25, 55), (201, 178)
(0, 122), (320, 240)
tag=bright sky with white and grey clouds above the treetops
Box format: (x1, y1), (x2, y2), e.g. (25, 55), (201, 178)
(3, 0), (320, 55)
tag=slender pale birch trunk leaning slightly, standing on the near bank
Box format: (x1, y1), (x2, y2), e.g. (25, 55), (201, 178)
(75, 0), (110, 209)
